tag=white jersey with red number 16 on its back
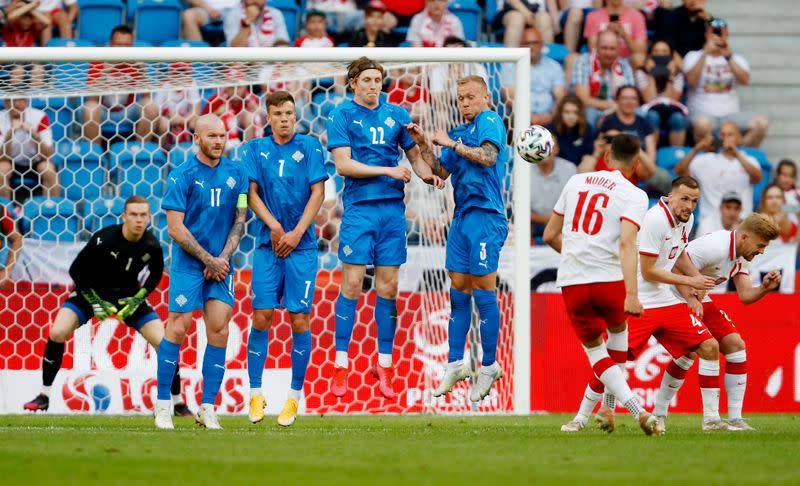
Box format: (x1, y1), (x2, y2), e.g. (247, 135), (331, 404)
(553, 171), (647, 287)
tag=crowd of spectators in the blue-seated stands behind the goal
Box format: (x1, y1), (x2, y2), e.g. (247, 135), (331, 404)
(0, 0), (800, 288)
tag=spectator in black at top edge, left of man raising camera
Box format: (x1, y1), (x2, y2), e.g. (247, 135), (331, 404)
(655, 0), (711, 57)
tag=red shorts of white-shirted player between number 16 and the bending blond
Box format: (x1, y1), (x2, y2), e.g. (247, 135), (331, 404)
(628, 304), (713, 360)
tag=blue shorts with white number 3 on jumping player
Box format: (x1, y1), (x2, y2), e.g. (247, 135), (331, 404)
(445, 208), (508, 276)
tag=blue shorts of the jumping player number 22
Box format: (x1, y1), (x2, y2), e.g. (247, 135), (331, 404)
(339, 199), (406, 267)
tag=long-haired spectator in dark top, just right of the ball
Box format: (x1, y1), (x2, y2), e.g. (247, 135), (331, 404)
(547, 94), (595, 166)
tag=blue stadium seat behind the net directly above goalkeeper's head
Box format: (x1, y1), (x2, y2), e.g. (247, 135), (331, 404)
(109, 141), (167, 198)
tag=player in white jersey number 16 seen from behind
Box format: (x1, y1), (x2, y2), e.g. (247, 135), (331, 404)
(544, 135), (657, 435)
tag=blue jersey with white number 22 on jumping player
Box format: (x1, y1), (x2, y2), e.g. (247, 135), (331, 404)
(327, 100), (416, 207)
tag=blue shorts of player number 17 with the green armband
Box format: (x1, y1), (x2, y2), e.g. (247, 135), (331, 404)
(169, 270), (233, 312)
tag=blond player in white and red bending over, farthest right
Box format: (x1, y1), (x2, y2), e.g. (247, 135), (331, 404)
(654, 213), (781, 430)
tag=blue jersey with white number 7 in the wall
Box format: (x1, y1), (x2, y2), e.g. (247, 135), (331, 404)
(242, 134), (328, 250)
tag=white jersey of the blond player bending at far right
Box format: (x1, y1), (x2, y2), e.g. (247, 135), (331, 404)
(675, 230), (750, 302)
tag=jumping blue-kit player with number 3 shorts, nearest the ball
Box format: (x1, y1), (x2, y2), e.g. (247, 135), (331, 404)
(408, 76), (508, 402)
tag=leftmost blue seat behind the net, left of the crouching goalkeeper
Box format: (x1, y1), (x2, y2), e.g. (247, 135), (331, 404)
(22, 196), (80, 241)
